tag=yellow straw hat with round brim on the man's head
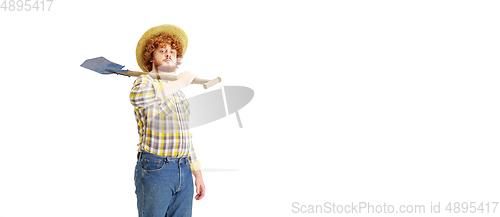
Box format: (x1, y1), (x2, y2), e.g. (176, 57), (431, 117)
(135, 24), (188, 72)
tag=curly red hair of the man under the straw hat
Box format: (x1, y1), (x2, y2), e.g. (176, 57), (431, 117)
(143, 32), (184, 71)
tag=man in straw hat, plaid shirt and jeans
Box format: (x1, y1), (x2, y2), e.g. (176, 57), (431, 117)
(130, 25), (205, 217)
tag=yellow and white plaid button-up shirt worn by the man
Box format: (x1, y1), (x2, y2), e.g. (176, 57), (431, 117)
(130, 75), (201, 171)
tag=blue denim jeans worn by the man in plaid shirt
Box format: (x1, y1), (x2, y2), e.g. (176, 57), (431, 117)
(134, 152), (194, 217)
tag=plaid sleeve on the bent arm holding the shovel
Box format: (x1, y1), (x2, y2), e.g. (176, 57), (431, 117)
(130, 75), (174, 115)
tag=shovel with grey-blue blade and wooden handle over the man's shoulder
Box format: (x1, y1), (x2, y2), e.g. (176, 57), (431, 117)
(80, 57), (222, 89)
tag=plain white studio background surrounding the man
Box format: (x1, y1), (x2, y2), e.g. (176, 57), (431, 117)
(0, 0), (500, 217)
